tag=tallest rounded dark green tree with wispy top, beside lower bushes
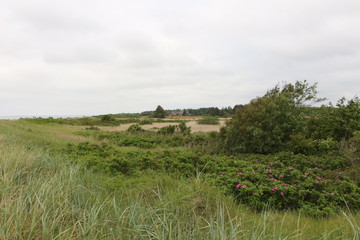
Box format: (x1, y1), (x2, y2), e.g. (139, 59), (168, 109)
(220, 80), (323, 153)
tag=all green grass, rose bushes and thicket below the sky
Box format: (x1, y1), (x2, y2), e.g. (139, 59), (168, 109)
(0, 81), (360, 239)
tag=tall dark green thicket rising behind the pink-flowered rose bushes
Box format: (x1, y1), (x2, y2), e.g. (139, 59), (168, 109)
(220, 81), (360, 154)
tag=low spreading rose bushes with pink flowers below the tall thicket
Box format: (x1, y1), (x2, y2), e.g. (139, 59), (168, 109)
(64, 142), (360, 217)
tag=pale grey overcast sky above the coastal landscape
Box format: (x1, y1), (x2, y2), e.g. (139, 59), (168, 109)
(0, 0), (360, 116)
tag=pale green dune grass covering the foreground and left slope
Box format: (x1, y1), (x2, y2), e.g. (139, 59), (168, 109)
(0, 121), (360, 239)
